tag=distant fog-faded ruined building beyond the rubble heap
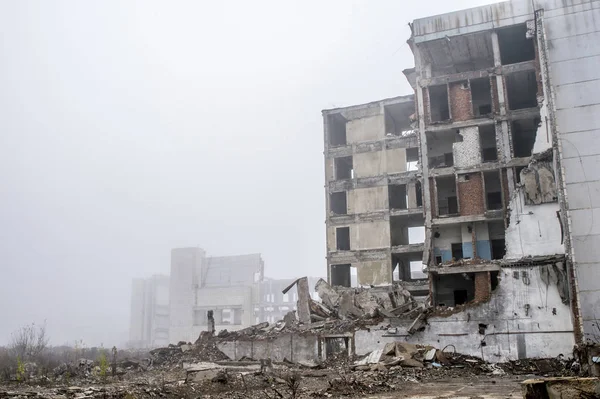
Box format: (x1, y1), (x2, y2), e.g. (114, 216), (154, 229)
(129, 247), (318, 347)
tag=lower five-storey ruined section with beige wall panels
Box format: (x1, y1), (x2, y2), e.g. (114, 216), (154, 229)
(323, 96), (428, 294)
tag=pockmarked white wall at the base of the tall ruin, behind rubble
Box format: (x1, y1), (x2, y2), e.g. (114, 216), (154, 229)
(355, 266), (575, 362)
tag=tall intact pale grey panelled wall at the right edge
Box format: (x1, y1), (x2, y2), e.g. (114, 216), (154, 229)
(536, 0), (600, 341)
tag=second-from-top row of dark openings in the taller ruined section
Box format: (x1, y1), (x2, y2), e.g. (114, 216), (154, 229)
(427, 70), (538, 123)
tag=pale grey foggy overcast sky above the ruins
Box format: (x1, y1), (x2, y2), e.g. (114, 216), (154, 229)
(0, 0), (491, 346)
